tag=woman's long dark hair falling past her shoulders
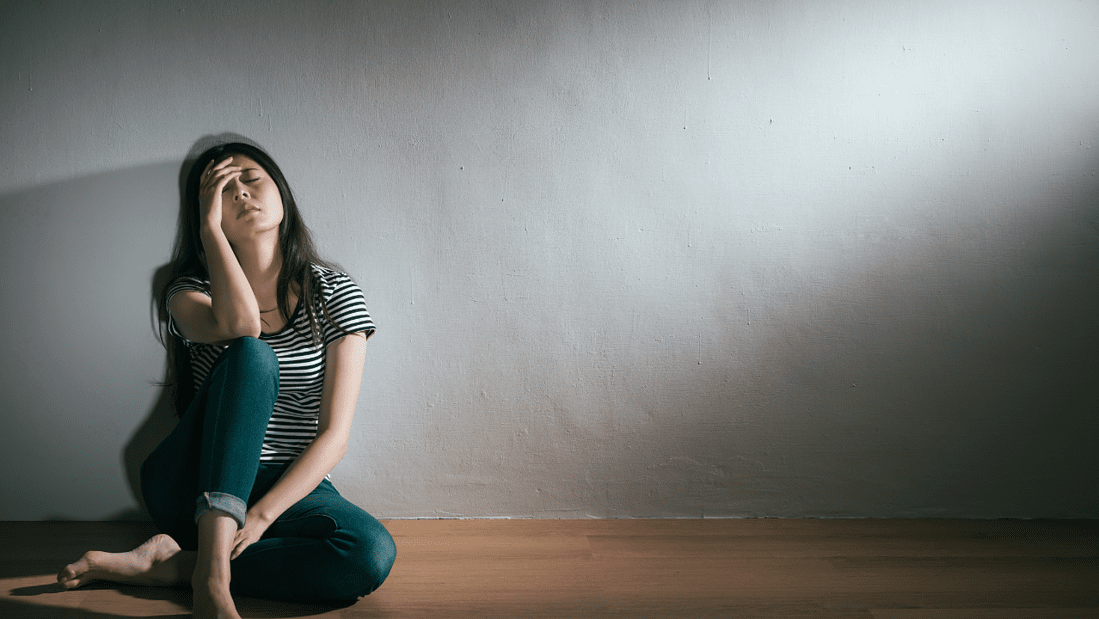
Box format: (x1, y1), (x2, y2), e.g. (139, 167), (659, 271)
(156, 142), (340, 416)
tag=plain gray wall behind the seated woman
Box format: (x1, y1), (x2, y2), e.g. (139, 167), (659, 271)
(0, 0), (1099, 519)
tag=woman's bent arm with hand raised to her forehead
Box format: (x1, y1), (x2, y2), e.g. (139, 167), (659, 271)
(169, 158), (263, 344)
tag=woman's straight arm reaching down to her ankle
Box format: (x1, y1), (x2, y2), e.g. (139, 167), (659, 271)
(231, 333), (366, 559)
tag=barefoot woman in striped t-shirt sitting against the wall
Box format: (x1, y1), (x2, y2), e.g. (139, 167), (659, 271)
(57, 143), (396, 618)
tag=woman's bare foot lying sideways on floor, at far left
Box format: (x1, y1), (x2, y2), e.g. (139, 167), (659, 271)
(57, 533), (195, 589)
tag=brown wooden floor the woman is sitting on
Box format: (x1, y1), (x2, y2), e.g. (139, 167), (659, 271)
(0, 519), (1099, 619)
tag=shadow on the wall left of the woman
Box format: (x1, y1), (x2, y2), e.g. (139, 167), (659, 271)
(0, 157), (179, 520)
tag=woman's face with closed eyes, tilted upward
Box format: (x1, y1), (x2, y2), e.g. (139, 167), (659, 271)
(221, 155), (282, 244)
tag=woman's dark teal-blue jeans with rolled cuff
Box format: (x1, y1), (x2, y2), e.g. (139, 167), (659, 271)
(141, 338), (397, 604)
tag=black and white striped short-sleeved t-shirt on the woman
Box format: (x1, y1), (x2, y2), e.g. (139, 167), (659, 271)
(167, 265), (374, 463)
